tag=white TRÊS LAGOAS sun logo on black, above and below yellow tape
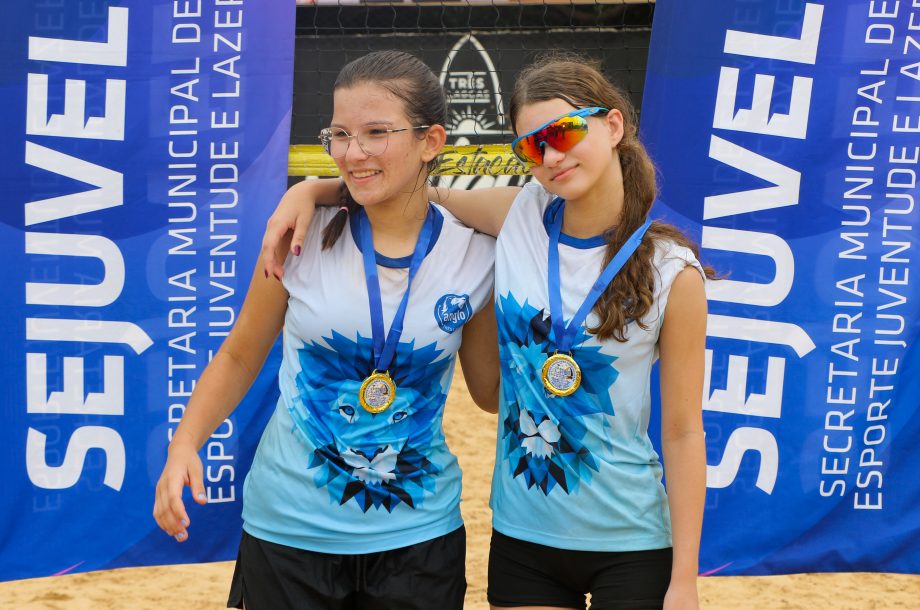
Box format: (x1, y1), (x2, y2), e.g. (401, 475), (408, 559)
(440, 34), (524, 189)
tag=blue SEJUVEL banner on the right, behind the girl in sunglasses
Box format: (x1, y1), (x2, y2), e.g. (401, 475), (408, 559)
(642, 0), (920, 575)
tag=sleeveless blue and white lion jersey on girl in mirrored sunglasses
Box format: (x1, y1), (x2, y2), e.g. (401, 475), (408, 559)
(491, 182), (702, 551)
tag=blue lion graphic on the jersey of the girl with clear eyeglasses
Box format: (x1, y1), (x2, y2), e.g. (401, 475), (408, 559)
(290, 331), (451, 512)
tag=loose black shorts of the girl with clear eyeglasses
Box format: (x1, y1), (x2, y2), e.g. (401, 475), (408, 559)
(227, 527), (466, 610)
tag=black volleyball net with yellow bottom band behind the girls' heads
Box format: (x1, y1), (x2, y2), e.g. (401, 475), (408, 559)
(288, 0), (655, 180)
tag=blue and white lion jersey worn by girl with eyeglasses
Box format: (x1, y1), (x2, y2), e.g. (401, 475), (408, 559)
(243, 206), (495, 554)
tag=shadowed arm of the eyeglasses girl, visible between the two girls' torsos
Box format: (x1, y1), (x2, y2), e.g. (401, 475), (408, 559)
(459, 297), (501, 413)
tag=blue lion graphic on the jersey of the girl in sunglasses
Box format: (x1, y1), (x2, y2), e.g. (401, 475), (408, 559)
(498, 293), (618, 495)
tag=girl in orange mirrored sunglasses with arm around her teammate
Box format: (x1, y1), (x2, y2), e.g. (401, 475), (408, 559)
(263, 58), (713, 610)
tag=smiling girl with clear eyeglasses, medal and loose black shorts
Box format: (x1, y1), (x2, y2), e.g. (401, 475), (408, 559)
(154, 51), (499, 610)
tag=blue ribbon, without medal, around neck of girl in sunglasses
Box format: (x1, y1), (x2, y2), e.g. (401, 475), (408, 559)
(547, 198), (652, 353)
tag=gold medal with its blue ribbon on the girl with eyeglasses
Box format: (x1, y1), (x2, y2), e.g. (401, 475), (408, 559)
(353, 206), (434, 413)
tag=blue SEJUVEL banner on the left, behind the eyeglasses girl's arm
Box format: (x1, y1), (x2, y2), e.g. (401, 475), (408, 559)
(0, 0), (294, 580)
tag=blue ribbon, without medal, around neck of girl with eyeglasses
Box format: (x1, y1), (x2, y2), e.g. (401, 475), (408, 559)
(355, 205), (434, 371)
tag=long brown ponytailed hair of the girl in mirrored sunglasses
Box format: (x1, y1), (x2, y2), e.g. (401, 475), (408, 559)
(510, 54), (716, 342)
